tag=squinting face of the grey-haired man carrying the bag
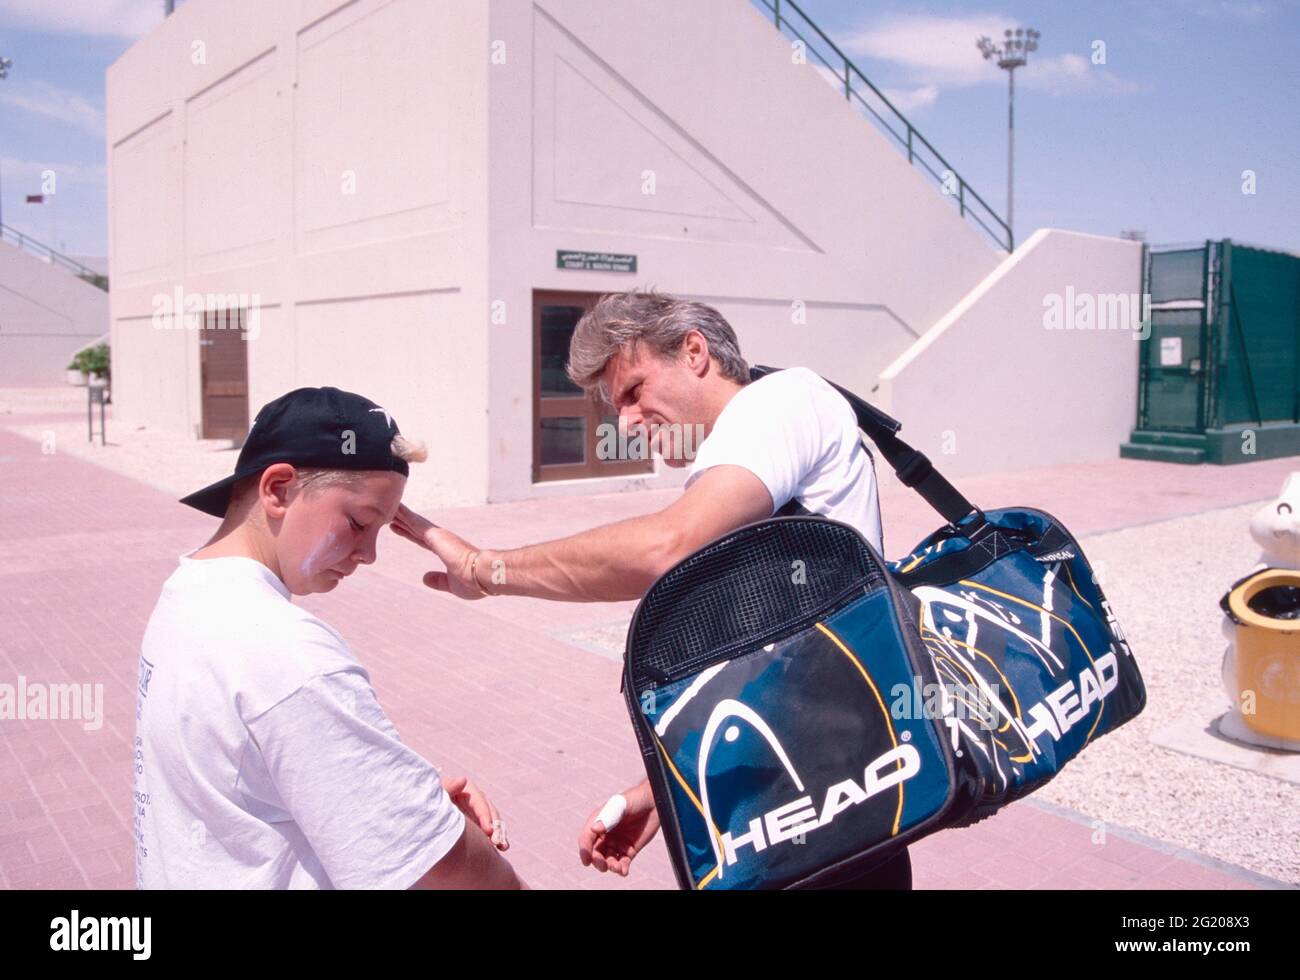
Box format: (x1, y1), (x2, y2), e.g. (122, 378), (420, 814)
(602, 344), (709, 467)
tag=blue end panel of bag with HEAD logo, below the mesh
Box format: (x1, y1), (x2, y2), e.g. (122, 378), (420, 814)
(642, 591), (948, 889)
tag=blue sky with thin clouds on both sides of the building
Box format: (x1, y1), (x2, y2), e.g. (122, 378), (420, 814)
(0, 0), (1300, 255)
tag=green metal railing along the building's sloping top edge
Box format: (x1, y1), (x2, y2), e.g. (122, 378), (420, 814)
(753, 0), (1014, 252)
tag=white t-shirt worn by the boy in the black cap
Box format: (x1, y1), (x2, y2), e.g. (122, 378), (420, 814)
(134, 556), (464, 889)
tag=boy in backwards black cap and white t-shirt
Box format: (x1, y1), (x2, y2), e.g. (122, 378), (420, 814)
(134, 387), (523, 888)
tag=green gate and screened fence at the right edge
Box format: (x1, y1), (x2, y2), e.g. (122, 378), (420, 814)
(1121, 239), (1300, 463)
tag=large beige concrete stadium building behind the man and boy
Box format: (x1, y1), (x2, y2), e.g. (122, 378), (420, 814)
(107, 0), (1140, 502)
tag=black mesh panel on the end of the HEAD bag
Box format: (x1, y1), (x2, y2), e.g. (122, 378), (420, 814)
(628, 517), (885, 689)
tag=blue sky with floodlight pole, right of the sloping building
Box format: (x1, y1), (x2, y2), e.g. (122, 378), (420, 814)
(797, 0), (1300, 251)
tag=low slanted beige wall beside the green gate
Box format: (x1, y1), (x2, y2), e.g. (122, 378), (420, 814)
(868, 229), (1141, 473)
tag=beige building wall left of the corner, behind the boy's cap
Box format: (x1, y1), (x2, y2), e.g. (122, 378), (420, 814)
(107, 0), (488, 500)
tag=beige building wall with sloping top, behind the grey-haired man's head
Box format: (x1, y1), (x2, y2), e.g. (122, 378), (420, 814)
(489, 0), (1002, 499)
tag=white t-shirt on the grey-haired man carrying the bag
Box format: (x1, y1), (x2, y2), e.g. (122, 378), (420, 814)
(686, 368), (881, 551)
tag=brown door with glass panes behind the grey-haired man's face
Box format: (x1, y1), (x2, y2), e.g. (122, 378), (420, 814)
(533, 292), (654, 482)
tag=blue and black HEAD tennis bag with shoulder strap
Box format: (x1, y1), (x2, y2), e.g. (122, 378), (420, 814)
(623, 368), (1147, 889)
